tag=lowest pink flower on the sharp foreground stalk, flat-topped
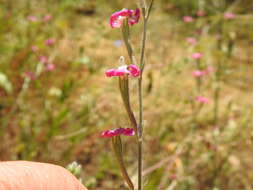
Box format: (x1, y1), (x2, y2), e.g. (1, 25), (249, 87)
(101, 128), (135, 138)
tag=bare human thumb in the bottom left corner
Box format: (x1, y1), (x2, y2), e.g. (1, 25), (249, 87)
(0, 161), (87, 190)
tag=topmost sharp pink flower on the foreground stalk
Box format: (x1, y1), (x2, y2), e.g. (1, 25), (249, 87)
(110, 8), (140, 28)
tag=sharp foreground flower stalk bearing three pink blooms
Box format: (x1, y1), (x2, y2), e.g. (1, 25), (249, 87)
(101, 0), (154, 190)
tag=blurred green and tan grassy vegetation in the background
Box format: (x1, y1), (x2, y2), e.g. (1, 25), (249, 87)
(0, 0), (253, 190)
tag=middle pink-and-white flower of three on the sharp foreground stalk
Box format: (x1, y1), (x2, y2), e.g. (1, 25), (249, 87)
(105, 65), (140, 77)
